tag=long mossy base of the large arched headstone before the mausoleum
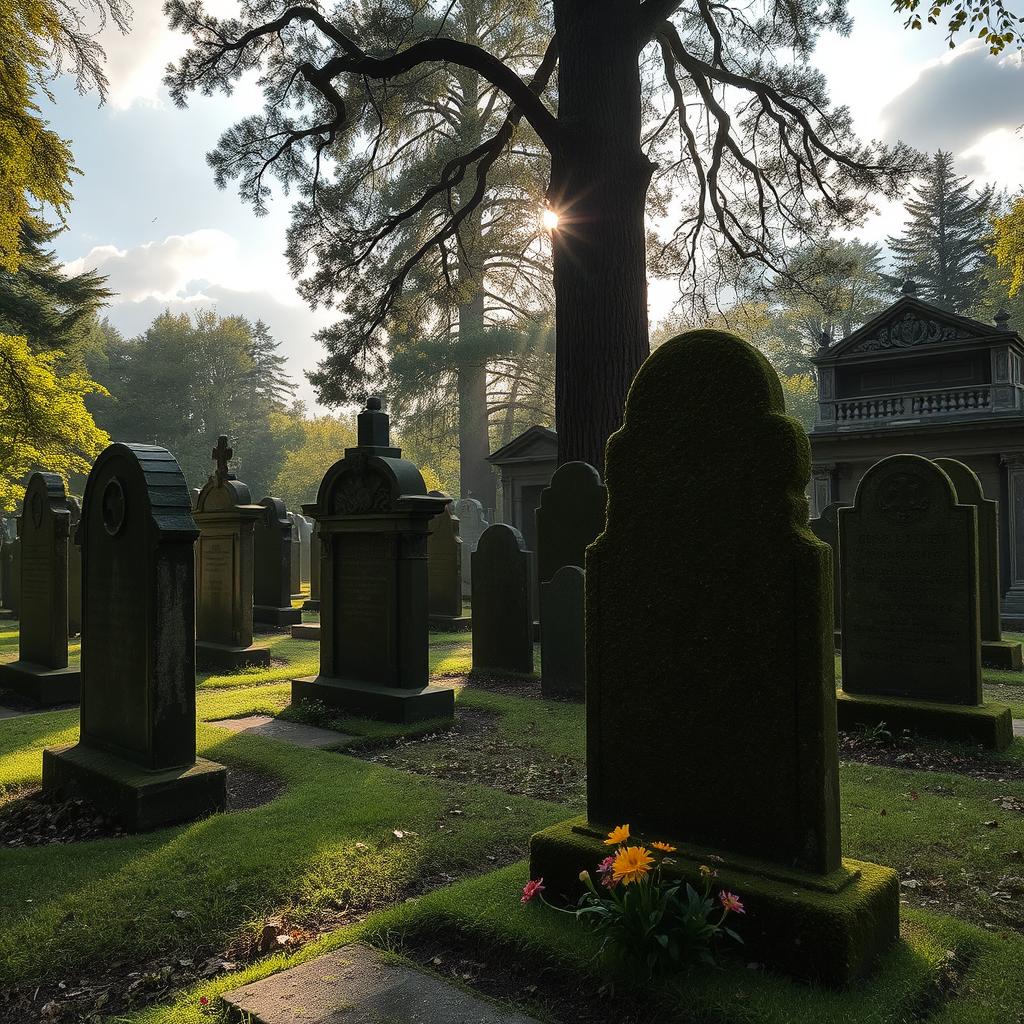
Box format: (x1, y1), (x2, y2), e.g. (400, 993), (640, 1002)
(836, 690), (1014, 751)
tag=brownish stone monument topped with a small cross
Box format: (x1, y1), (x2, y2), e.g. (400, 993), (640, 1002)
(193, 434), (270, 669)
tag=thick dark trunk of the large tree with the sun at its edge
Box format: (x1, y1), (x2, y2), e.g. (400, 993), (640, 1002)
(550, 0), (653, 473)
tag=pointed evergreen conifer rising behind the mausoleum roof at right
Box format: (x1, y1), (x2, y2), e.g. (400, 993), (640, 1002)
(887, 150), (993, 315)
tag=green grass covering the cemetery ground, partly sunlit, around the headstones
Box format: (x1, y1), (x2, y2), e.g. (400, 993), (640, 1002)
(0, 624), (1024, 1024)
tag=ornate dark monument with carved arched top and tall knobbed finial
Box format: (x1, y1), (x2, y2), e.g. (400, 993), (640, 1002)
(292, 398), (455, 722)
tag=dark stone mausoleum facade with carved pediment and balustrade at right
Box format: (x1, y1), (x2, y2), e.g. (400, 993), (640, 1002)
(810, 282), (1024, 626)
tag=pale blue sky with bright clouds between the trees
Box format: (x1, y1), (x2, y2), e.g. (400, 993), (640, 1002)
(43, 0), (1024, 410)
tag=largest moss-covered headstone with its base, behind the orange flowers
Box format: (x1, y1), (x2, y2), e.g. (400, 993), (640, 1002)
(530, 331), (899, 985)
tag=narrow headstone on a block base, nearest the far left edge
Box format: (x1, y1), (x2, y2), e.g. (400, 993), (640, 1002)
(0, 473), (82, 707)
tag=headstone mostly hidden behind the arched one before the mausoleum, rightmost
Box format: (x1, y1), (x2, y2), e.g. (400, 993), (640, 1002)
(935, 459), (1022, 670)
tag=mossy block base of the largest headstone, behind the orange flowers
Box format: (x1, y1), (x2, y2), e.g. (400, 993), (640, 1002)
(529, 817), (899, 988)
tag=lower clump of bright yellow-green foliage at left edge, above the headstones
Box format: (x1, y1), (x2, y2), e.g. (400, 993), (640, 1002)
(0, 333), (110, 509)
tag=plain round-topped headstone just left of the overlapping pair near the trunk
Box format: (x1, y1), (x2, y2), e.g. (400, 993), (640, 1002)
(471, 524), (534, 675)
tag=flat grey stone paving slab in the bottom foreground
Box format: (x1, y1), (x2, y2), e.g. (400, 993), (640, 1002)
(221, 943), (537, 1024)
